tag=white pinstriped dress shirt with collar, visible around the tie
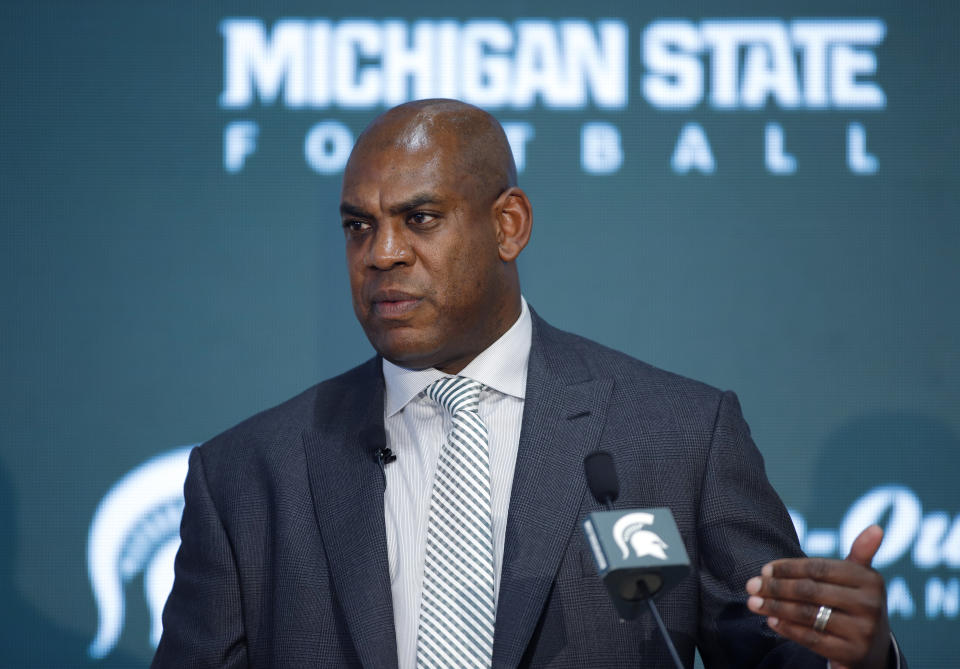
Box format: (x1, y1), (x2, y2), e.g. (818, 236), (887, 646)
(383, 297), (533, 669)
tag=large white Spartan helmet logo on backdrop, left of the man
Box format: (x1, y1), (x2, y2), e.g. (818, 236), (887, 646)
(87, 446), (192, 659)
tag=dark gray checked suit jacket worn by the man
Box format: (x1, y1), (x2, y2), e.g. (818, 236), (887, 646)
(153, 314), (840, 669)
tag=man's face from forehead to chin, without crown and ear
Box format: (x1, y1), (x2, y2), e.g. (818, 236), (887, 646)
(341, 133), (517, 373)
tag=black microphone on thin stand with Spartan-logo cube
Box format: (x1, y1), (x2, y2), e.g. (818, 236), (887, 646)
(583, 451), (690, 669)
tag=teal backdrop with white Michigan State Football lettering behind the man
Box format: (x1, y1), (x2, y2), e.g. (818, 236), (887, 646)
(0, 0), (960, 667)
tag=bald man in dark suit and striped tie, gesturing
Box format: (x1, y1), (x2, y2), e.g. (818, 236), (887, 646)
(154, 100), (900, 667)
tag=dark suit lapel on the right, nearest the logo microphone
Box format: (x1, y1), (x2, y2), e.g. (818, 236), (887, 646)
(493, 315), (613, 667)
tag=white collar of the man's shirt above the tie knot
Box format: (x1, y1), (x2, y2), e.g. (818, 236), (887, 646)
(383, 296), (533, 417)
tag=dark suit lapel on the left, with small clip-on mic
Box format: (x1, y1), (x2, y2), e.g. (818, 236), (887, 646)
(302, 358), (397, 667)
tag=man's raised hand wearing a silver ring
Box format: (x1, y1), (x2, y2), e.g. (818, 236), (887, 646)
(747, 525), (890, 669)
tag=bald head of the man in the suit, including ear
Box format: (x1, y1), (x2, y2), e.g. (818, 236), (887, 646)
(340, 100), (532, 373)
